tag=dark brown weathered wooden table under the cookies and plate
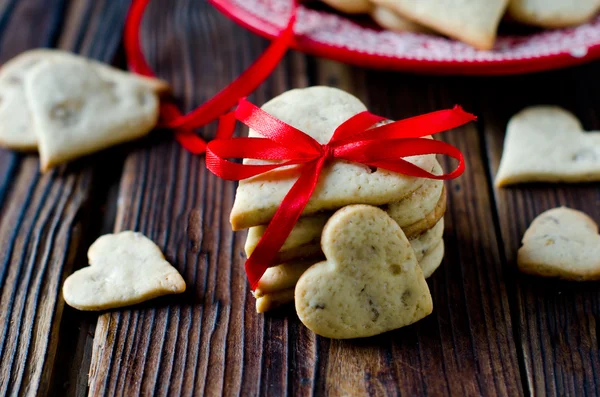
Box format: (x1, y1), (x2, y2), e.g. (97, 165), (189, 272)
(0, 0), (600, 396)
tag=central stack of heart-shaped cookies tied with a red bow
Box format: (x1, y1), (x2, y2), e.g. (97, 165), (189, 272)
(231, 87), (446, 337)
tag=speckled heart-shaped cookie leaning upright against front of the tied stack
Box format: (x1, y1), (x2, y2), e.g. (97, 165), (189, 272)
(295, 205), (433, 339)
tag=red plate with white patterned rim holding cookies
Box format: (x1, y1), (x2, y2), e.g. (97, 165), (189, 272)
(210, 0), (600, 75)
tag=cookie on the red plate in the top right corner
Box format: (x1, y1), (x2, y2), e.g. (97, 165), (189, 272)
(508, 0), (600, 28)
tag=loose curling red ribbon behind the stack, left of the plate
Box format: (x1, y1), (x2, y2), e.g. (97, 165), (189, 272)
(124, 0), (297, 154)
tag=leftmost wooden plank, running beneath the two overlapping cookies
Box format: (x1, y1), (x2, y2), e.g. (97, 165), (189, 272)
(0, 0), (132, 395)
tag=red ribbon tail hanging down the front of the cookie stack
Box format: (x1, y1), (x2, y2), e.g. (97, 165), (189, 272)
(246, 158), (325, 291)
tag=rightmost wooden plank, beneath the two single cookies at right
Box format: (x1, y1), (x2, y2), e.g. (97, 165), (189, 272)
(481, 63), (600, 396)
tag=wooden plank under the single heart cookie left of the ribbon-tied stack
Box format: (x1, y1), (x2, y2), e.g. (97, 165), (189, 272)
(90, 0), (292, 396)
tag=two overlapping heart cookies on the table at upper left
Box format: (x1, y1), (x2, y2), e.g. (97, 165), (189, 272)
(0, 49), (168, 170)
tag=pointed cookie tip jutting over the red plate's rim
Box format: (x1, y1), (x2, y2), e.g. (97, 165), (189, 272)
(373, 0), (508, 50)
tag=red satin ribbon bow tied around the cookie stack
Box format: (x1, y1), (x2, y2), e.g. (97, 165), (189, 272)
(206, 99), (476, 290)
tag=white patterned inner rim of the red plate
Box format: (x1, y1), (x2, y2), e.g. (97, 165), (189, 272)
(212, 0), (600, 63)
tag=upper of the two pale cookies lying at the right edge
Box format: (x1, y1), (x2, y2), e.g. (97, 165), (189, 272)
(496, 106), (600, 186)
